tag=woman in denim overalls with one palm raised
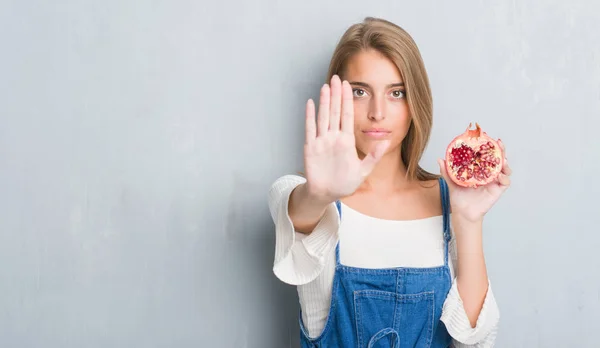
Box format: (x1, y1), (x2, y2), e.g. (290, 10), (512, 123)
(269, 18), (510, 347)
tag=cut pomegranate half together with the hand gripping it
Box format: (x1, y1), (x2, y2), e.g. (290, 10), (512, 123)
(438, 124), (512, 222)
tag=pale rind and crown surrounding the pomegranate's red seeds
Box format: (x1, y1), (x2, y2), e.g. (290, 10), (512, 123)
(445, 123), (504, 188)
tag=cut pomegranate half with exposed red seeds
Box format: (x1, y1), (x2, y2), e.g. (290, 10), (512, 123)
(446, 123), (504, 188)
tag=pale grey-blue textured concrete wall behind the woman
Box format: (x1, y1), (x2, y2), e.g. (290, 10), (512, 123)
(0, 0), (600, 348)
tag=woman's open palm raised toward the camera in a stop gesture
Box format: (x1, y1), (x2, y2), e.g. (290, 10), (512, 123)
(304, 75), (389, 202)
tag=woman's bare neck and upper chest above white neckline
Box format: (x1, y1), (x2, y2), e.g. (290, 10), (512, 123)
(363, 148), (409, 191)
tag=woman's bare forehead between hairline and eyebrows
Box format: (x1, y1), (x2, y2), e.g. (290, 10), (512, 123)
(344, 50), (403, 85)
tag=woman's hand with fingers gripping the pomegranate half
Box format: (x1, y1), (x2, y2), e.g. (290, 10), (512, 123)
(438, 140), (512, 222)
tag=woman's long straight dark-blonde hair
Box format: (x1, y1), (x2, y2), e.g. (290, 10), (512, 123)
(326, 17), (439, 181)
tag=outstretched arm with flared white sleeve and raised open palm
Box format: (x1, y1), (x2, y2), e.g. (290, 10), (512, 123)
(269, 75), (389, 284)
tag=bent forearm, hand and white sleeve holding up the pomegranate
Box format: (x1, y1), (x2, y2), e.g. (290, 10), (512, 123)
(438, 141), (512, 347)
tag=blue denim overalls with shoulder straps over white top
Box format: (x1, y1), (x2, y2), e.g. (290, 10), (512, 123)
(299, 178), (452, 348)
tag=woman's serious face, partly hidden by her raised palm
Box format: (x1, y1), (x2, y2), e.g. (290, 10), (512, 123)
(343, 50), (410, 156)
